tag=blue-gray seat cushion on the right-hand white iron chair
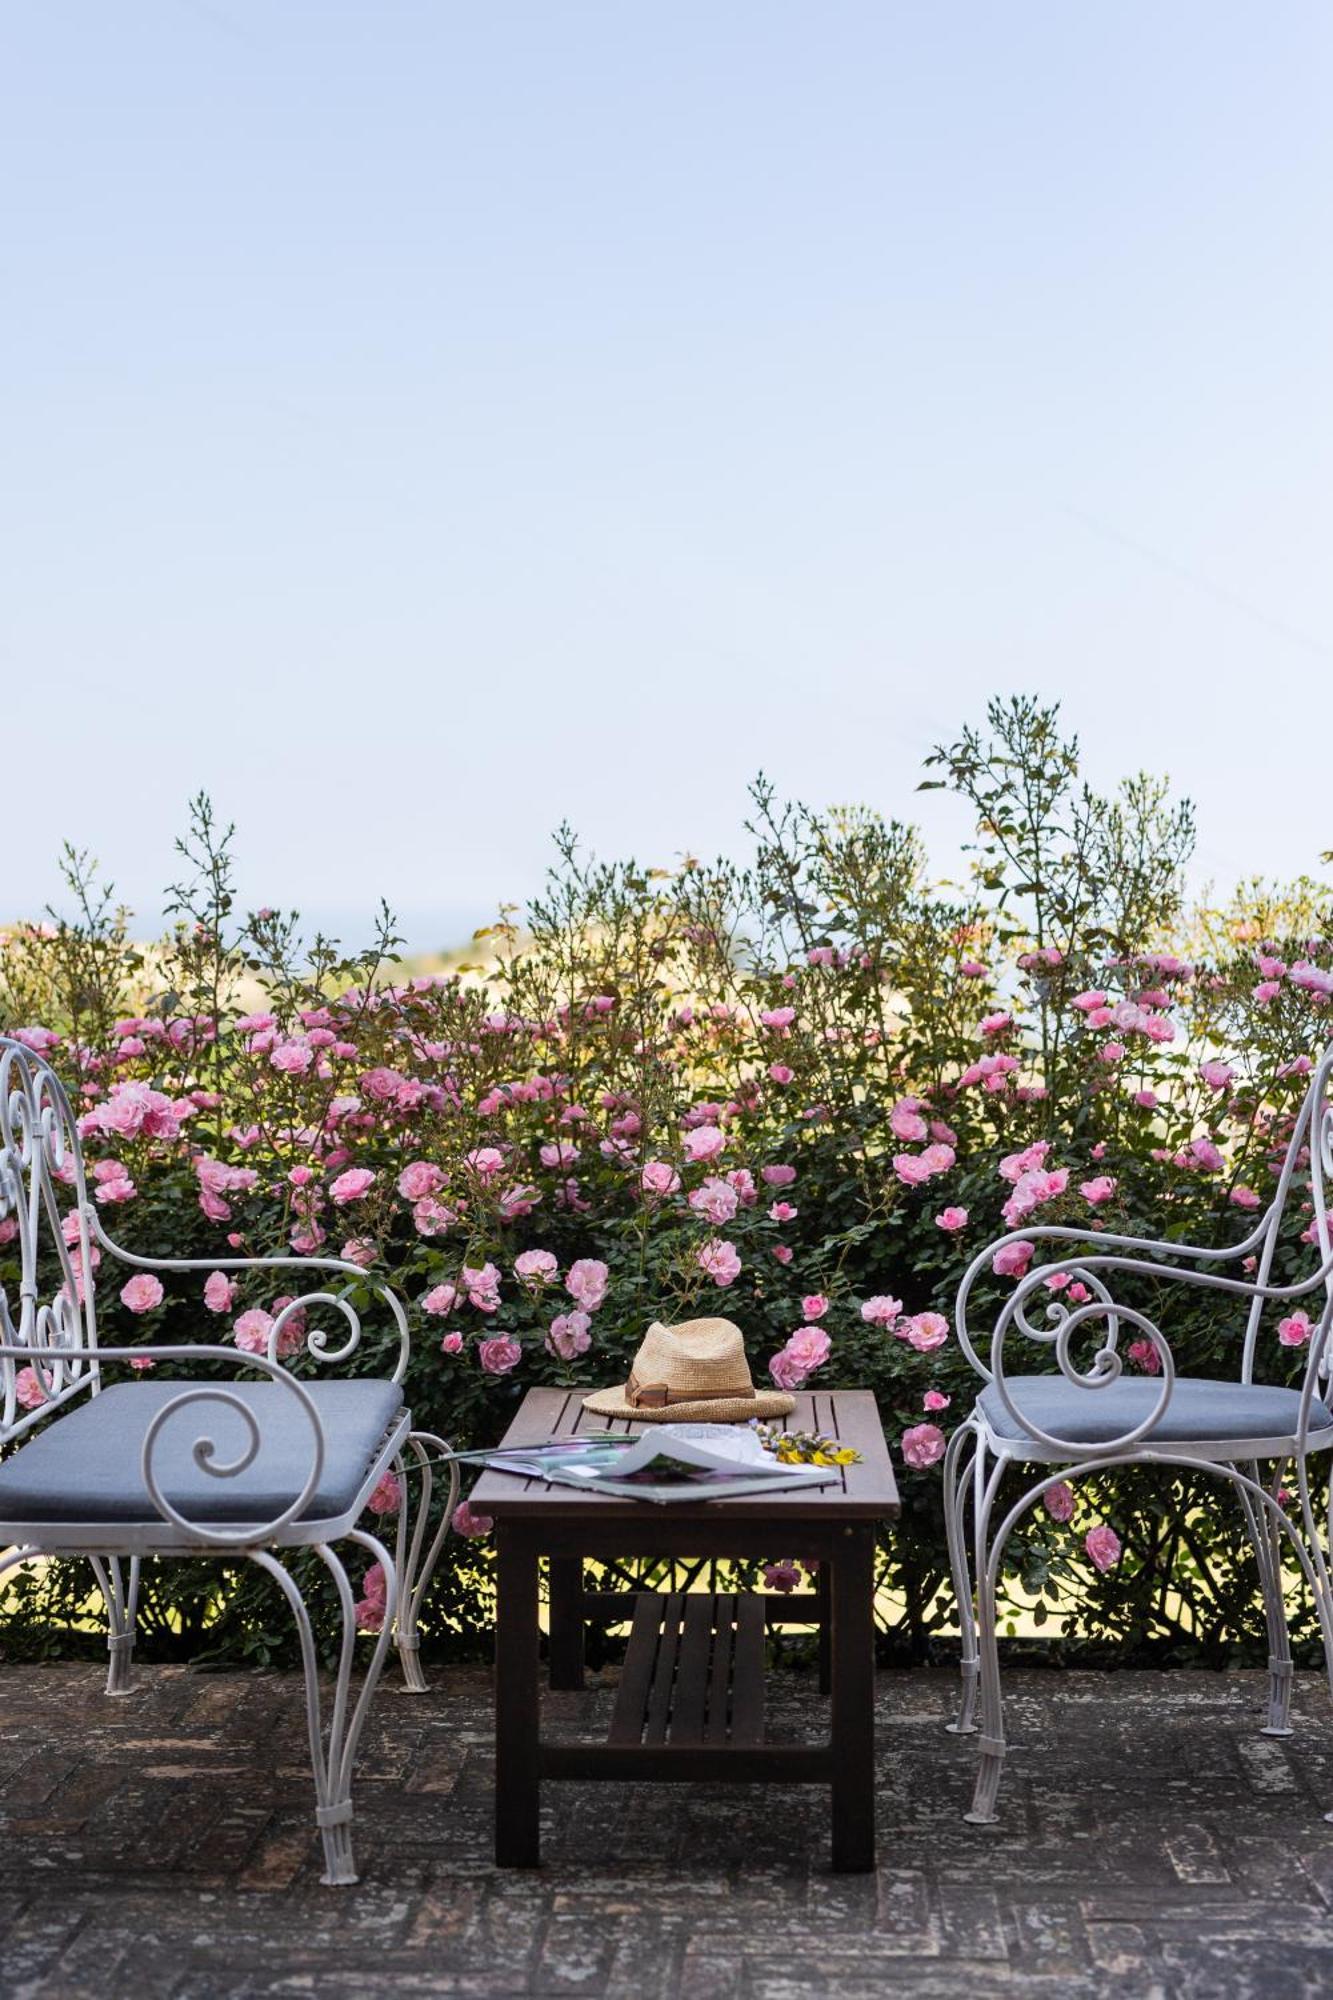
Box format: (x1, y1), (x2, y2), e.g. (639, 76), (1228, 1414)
(979, 1376), (1333, 1444)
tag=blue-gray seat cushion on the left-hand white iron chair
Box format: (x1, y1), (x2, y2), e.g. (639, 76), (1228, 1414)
(0, 1376), (402, 1522)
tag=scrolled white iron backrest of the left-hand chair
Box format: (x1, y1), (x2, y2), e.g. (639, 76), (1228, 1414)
(0, 1036), (100, 1442)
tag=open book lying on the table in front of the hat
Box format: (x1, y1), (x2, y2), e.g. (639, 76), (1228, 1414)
(478, 1424), (841, 1506)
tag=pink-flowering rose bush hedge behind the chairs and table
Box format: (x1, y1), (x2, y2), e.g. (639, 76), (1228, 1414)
(0, 700), (1333, 1658)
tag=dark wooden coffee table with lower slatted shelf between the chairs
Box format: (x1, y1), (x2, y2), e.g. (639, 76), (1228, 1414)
(470, 1388), (899, 1870)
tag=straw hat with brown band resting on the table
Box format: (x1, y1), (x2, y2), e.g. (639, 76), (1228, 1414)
(582, 1320), (797, 1424)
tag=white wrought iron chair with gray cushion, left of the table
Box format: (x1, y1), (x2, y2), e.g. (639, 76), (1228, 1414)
(0, 1038), (458, 1884)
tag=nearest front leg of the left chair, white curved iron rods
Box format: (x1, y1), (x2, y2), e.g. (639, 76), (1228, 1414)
(248, 1528), (398, 1888)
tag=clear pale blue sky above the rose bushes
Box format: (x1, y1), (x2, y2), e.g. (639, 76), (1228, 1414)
(0, 0), (1333, 948)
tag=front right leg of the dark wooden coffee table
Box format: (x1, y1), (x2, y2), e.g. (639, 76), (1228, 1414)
(827, 1526), (875, 1872)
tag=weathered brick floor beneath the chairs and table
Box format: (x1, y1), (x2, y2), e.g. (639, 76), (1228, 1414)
(0, 1666), (1333, 2000)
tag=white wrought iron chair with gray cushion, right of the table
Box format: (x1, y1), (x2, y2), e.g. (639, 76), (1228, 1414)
(945, 1048), (1333, 1826)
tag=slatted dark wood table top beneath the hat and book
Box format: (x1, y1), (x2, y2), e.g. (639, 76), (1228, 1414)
(468, 1388), (899, 1528)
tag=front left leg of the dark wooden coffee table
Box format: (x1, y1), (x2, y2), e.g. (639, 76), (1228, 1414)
(494, 1522), (540, 1868)
